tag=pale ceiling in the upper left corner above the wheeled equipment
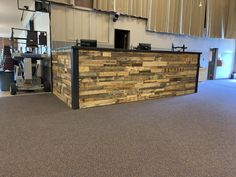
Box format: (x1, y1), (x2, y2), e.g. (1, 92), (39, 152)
(0, 0), (32, 37)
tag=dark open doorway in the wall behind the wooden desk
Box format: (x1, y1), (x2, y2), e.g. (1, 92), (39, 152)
(114, 29), (130, 49)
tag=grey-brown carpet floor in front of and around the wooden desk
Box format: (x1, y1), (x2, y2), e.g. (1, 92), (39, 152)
(0, 81), (236, 177)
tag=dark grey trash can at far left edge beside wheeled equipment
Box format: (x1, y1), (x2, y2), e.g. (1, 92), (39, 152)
(0, 71), (14, 91)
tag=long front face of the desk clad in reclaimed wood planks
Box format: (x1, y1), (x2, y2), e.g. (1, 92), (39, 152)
(79, 50), (198, 108)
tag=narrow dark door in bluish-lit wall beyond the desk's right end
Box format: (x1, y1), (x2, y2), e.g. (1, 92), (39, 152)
(207, 48), (218, 80)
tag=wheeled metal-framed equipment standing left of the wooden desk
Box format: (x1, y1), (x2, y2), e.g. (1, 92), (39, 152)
(10, 28), (51, 95)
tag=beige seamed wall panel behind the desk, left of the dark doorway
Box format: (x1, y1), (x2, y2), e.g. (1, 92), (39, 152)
(51, 5), (110, 45)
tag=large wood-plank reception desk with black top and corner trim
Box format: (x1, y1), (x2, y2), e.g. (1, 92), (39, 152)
(52, 47), (201, 109)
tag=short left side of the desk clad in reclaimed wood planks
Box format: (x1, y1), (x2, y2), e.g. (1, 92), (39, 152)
(52, 52), (72, 107)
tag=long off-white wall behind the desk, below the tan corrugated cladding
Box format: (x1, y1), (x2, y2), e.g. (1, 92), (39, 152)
(52, 8), (236, 79)
